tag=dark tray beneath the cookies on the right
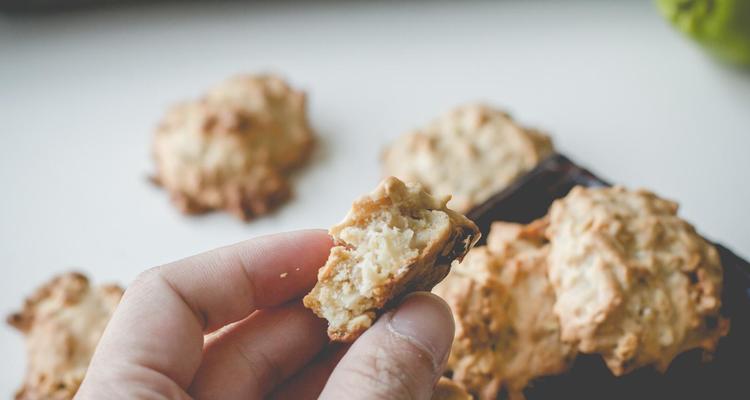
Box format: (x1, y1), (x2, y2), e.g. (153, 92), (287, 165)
(467, 154), (750, 400)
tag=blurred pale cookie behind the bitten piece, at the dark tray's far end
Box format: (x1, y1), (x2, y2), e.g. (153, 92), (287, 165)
(382, 105), (553, 212)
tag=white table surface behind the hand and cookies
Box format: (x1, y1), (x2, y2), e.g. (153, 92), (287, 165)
(0, 1), (750, 398)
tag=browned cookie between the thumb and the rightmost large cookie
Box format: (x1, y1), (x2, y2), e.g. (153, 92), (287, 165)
(434, 222), (576, 399)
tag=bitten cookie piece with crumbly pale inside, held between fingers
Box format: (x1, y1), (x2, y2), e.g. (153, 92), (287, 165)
(304, 177), (479, 342)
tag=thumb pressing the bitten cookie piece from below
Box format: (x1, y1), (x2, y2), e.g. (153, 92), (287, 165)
(320, 292), (454, 400)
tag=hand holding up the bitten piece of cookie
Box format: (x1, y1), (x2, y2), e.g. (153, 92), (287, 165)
(76, 231), (454, 399)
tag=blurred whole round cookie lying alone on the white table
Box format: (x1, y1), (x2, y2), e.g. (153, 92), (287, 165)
(153, 75), (314, 220)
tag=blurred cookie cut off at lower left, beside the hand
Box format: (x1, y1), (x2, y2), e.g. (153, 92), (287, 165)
(8, 273), (123, 400)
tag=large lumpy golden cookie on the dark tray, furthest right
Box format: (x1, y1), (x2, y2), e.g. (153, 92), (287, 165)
(547, 187), (729, 375)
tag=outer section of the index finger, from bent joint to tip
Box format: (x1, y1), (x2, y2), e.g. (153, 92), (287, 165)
(158, 230), (333, 332)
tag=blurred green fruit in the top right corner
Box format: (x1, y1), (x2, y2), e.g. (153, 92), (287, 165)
(656, 0), (750, 66)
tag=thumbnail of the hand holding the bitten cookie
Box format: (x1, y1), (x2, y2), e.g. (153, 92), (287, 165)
(388, 292), (454, 366)
